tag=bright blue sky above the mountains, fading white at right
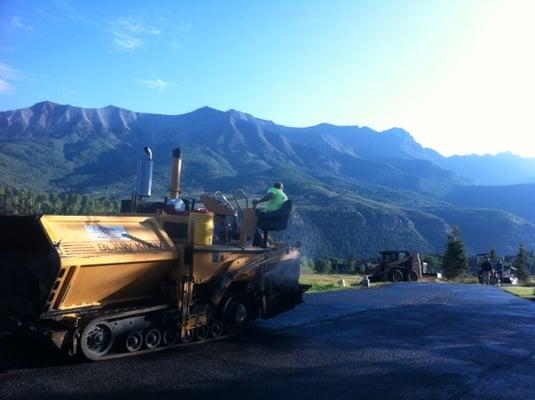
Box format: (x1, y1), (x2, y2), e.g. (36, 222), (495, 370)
(0, 0), (535, 156)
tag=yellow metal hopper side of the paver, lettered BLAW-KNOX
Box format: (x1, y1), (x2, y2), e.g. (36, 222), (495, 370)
(41, 215), (179, 310)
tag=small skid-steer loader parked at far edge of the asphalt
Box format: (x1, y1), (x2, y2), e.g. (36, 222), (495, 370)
(369, 251), (422, 282)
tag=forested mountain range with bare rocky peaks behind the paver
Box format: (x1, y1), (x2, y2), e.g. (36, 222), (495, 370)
(0, 102), (535, 257)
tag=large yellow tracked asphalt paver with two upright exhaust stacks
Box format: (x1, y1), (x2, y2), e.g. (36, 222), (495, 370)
(0, 149), (306, 361)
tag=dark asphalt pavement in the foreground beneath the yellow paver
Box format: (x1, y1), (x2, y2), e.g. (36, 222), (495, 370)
(0, 283), (535, 400)
